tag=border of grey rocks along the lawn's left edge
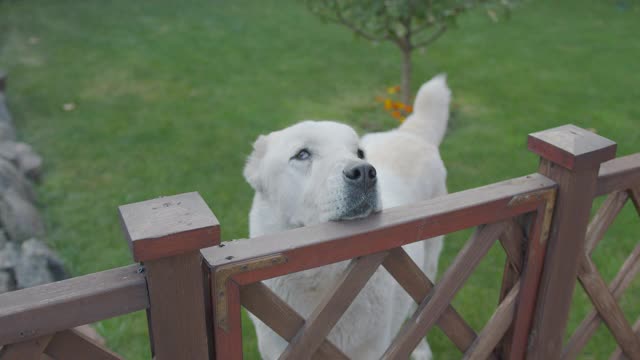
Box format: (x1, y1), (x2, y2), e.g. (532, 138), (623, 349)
(0, 70), (67, 292)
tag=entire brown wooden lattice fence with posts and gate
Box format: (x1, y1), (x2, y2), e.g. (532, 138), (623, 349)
(0, 125), (640, 360)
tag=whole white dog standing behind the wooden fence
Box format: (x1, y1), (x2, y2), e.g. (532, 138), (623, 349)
(244, 75), (451, 360)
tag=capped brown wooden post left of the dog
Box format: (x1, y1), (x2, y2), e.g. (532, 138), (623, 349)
(119, 192), (220, 360)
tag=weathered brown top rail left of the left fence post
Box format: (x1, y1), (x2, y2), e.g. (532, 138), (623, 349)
(0, 265), (149, 345)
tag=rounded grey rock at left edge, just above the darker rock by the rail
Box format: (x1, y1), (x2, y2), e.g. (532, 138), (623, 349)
(0, 188), (44, 242)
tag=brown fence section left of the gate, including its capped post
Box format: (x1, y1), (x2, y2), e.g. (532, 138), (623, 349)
(0, 193), (220, 360)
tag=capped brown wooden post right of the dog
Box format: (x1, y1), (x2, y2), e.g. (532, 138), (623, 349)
(527, 125), (616, 360)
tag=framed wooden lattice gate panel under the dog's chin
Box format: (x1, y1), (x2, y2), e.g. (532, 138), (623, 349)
(202, 174), (555, 359)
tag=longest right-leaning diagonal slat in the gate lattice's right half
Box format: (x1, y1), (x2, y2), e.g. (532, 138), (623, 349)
(382, 223), (505, 359)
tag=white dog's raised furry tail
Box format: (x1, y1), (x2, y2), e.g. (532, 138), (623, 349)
(399, 74), (451, 146)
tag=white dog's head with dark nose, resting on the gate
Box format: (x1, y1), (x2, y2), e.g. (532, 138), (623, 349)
(244, 121), (380, 226)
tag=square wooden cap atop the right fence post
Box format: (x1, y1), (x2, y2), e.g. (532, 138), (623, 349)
(528, 124), (617, 170)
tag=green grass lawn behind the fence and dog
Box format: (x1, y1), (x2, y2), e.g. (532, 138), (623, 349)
(0, 0), (640, 359)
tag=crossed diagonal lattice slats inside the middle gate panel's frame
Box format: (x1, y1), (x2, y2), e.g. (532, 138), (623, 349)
(240, 221), (523, 359)
